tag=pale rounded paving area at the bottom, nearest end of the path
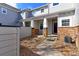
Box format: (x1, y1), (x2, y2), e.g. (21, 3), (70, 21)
(35, 48), (63, 56)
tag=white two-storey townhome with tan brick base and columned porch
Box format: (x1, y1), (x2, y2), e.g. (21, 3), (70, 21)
(21, 3), (79, 47)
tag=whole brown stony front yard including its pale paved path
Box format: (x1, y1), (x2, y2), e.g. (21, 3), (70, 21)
(21, 36), (79, 56)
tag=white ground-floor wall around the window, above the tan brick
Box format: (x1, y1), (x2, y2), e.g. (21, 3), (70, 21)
(58, 11), (75, 27)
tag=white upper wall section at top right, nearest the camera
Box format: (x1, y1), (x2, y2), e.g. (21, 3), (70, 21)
(49, 3), (75, 13)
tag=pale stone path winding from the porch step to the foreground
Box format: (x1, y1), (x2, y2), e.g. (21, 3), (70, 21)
(35, 37), (63, 56)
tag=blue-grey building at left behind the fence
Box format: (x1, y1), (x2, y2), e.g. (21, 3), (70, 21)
(0, 3), (22, 26)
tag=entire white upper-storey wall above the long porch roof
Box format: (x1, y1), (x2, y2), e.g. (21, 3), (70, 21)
(24, 3), (76, 18)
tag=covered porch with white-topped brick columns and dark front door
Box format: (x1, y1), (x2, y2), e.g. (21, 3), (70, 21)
(23, 17), (57, 37)
